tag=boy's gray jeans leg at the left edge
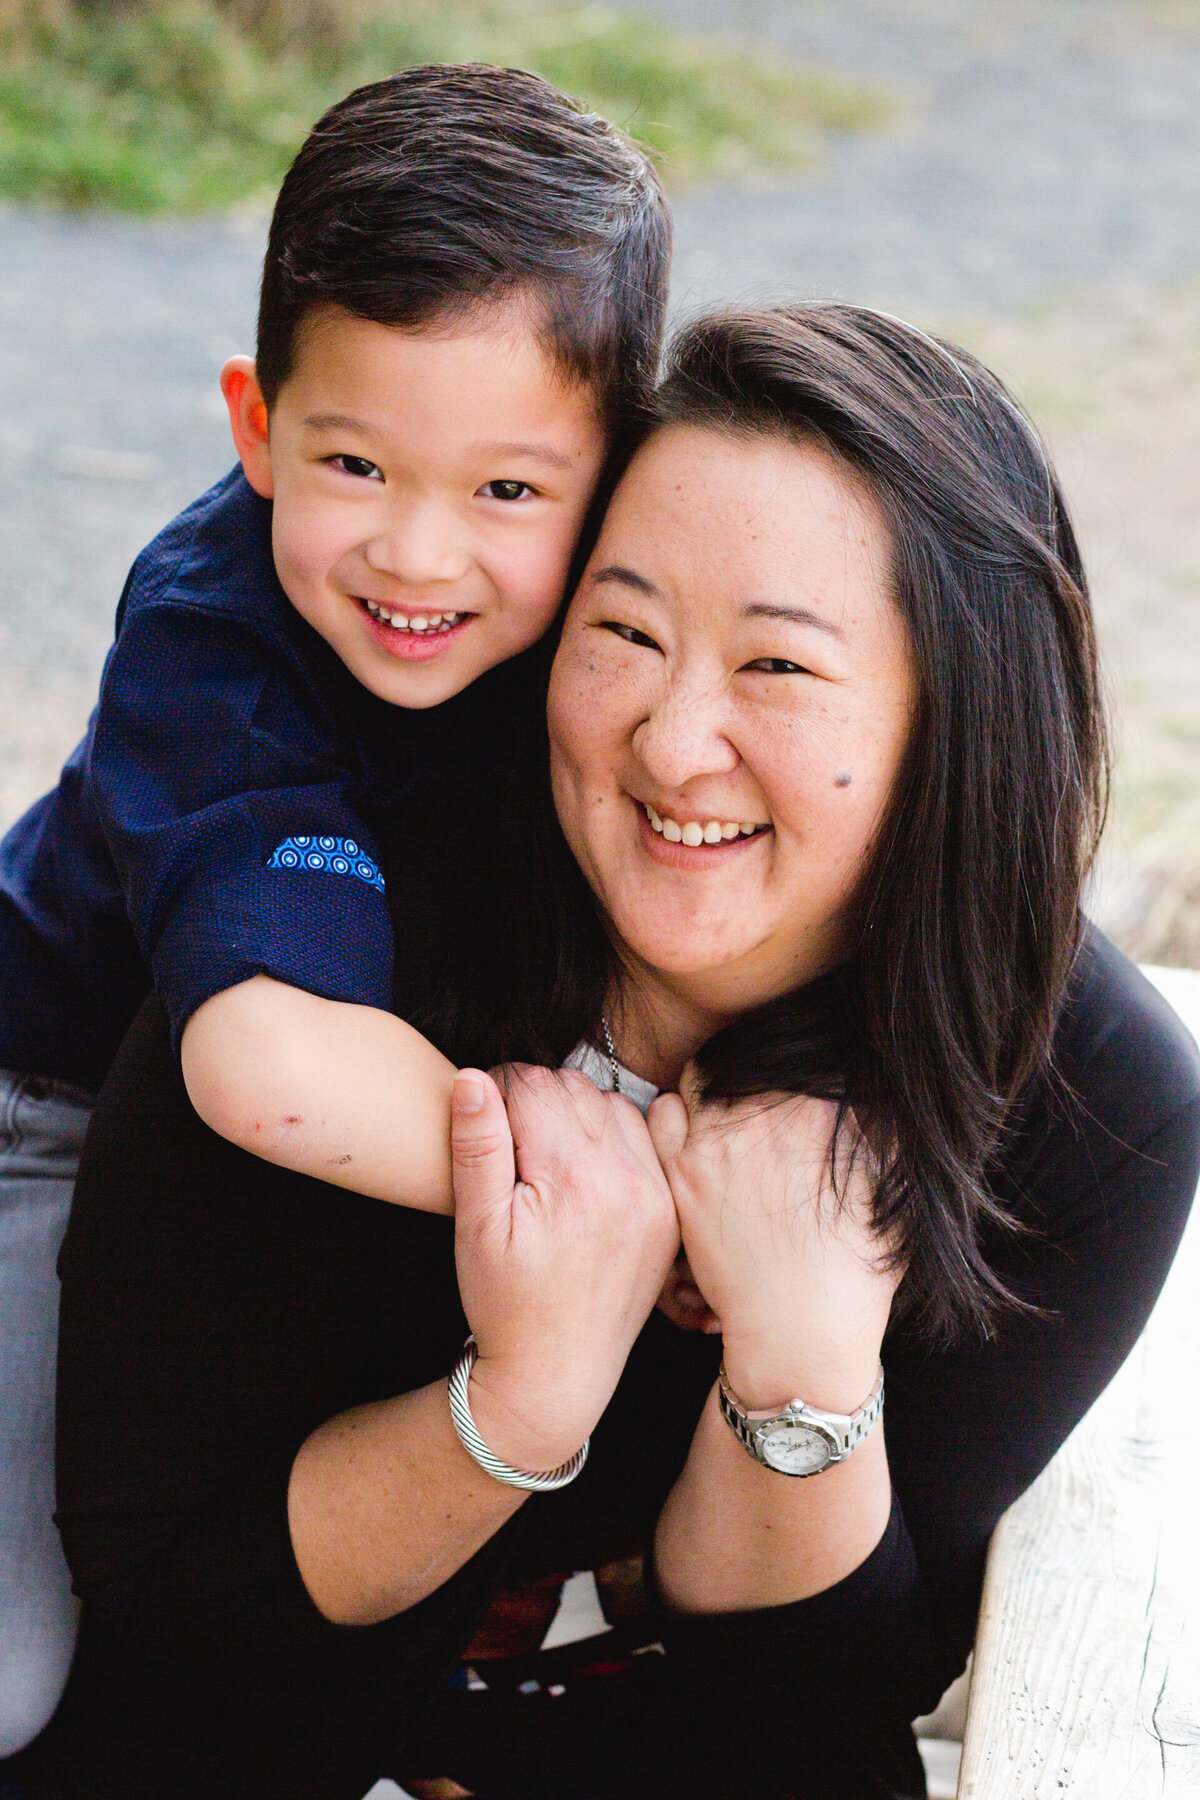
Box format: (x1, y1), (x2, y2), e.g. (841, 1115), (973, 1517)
(0, 1069), (90, 1757)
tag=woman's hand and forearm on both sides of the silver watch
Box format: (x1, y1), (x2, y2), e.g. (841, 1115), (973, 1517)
(649, 1073), (900, 1613)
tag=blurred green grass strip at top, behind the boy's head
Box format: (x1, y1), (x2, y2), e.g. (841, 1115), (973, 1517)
(0, 0), (885, 212)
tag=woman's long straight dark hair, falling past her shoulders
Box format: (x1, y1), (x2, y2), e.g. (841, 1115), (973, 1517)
(410, 306), (1106, 1337)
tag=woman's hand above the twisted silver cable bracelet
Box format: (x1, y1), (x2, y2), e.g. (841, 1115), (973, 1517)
(452, 1067), (678, 1469)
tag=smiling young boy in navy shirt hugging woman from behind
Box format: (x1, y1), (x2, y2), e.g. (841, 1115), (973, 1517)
(0, 65), (669, 1755)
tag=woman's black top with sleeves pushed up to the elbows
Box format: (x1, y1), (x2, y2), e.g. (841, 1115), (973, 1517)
(20, 936), (1200, 1800)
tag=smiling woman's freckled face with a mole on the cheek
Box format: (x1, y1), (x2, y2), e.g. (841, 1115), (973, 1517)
(551, 427), (916, 1013)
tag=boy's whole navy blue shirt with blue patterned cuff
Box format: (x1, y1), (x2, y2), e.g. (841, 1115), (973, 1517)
(0, 470), (525, 1091)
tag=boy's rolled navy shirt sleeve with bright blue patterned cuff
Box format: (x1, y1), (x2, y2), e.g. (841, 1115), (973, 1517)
(88, 603), (392, 1044)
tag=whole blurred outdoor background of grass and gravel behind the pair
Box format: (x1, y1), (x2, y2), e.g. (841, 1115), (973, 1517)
(0, 0), (1200, 967)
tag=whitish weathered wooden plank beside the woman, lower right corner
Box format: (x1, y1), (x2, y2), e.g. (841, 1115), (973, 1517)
(959, 970), (1200, 1800)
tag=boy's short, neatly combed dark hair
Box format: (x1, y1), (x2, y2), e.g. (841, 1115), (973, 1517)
(257, 63), (671, 428)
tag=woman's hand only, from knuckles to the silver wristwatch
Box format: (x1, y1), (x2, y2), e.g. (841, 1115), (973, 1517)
(649, 1076), (903, 1411)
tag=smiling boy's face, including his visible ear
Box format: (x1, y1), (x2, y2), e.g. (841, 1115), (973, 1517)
(221, 302), (604, 707)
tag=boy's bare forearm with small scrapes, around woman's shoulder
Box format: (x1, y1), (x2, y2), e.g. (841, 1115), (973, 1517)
(180, 976), (455, 1213)
